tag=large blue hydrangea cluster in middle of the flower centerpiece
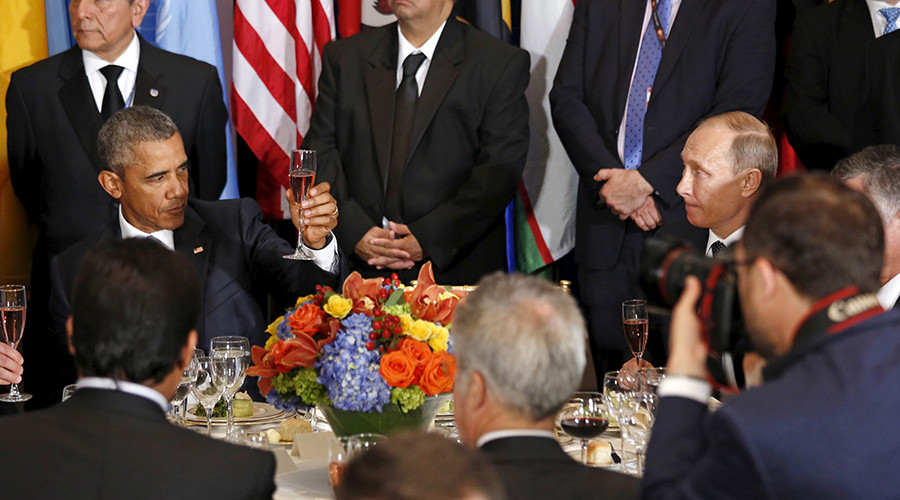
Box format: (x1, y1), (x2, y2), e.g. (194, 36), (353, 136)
(315, 313), (391, 412)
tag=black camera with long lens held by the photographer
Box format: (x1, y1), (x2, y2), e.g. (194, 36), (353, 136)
(641, 238), (752, 389)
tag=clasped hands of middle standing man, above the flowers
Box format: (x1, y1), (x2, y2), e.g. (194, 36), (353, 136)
(355, 222), (424, 269)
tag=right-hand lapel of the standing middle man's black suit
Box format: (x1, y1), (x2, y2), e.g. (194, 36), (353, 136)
(406, 17), (466, 167)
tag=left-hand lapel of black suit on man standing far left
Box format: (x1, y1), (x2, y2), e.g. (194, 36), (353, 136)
(59, 47), (103, 172)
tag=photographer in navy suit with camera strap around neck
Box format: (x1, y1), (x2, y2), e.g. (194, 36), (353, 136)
(643, 175), (900, 499)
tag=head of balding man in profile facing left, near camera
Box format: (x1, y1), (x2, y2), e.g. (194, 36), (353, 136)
(675, 111), (778, 257)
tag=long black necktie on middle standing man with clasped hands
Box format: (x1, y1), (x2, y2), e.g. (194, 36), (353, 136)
(384, 53), (425, 222)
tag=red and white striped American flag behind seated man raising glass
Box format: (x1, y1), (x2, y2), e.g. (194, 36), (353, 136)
(231, 0), (335, 219)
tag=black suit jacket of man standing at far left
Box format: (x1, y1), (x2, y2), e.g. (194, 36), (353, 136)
(6, 39), (227, 258)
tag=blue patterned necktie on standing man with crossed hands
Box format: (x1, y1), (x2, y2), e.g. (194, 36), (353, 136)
(624, 0), (669, 170)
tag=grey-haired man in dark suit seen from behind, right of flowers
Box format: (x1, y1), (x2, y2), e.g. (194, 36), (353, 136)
(453, 273), (639, 499)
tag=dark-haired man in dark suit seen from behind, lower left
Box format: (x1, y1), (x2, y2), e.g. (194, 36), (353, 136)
(0, 239), (275, 499)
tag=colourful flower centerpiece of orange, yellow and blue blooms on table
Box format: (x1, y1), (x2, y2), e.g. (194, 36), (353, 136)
(247, 263), (464, 435)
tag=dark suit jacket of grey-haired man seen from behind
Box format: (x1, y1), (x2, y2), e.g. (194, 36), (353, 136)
(481, 437), (640, 500)
